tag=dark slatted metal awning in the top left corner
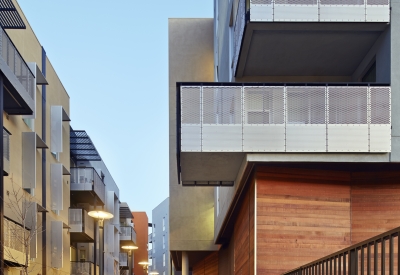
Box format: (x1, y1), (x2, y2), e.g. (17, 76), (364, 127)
(0, 0), (26, 29)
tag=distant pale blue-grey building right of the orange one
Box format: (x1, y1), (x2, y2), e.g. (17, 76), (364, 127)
(149, 198), (171, 275)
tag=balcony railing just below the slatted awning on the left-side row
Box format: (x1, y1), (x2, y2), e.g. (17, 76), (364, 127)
(71, 167), (105, 202)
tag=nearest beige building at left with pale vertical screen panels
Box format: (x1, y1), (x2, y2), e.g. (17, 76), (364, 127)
(0, 0), (70, 275)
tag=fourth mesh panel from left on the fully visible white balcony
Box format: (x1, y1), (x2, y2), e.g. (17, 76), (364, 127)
(286, 87), (325, 124)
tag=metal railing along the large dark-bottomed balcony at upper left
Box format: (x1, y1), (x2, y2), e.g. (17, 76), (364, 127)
(0, 29), (35, 99)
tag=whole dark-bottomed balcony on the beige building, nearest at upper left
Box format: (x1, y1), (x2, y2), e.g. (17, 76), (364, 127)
(0, 29), (36, 115)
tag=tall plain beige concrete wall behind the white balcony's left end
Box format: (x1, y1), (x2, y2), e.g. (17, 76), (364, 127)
(169, 19), (217, 251)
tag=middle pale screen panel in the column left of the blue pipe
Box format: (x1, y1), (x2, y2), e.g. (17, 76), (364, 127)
(22, 132), (36, 189)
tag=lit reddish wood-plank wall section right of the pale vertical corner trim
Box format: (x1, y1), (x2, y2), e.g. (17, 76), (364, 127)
(256, 168), (351, 274)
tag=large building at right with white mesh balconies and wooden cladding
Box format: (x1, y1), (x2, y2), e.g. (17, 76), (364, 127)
(169, 0), (400, 274)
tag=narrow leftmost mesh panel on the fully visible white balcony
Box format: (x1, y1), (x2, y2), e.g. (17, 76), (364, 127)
(181, 87), (201, 124)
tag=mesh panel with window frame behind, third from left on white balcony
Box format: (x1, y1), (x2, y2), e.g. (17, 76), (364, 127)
(243, 87), (285, 124)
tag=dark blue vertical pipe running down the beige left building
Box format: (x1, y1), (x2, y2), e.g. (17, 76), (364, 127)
(42, 47), (47, 275)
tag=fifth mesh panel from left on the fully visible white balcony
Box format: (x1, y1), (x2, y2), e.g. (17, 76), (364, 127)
(328, 87), (368, 124)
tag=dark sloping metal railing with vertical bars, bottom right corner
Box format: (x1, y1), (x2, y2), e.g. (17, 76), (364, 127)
(282, 227), (400, 275)
